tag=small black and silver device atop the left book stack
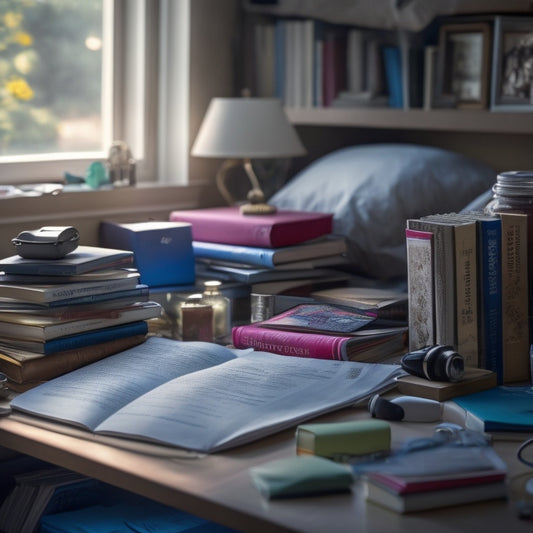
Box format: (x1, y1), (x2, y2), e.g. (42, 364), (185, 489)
(11, 226), (80, 259)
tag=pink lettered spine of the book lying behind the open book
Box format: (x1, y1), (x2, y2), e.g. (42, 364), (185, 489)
(233, 324), (347, 360)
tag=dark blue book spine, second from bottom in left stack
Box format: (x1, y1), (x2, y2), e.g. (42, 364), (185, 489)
(43, 320), (148, 355)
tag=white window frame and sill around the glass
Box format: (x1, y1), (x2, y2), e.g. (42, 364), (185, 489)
(0, 0), (162, 185)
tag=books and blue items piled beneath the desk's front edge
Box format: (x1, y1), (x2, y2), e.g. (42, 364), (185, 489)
(0, 464), (232, 533)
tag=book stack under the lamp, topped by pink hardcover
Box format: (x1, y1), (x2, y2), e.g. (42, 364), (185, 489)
(170, 207), (347, 285)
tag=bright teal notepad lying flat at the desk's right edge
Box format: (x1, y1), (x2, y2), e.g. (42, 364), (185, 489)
(454, 386), (533, 432)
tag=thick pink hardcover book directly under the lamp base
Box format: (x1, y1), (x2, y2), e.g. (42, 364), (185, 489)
(170, 207), (333, 248)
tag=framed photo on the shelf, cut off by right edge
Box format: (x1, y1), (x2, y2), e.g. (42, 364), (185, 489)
(491, 16), (533, 111)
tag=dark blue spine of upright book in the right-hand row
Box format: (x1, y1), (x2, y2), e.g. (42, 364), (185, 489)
(478, 219), (503, 384)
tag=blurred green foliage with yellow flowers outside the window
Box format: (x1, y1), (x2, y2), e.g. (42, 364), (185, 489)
(0, 0), (102, 156)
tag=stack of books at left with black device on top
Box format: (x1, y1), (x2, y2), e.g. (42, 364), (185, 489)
(0, 246), (161, 391)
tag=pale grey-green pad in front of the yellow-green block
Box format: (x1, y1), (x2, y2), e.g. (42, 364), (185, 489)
(250, 456), (354, 498)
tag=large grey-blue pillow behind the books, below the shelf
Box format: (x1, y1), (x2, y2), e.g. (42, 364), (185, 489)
(269, 144), (496, 280)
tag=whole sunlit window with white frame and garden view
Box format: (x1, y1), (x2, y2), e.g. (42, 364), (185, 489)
(0, 0), (189, 184)
